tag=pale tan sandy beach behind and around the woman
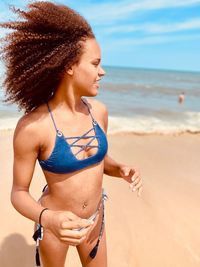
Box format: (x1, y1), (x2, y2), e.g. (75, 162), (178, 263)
(0, 131), (200, 267)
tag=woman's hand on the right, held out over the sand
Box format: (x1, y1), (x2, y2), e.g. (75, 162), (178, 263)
(120, 165), (143, 196)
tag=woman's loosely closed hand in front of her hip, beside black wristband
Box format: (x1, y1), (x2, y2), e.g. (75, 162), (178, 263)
(42, 210), (93, 246)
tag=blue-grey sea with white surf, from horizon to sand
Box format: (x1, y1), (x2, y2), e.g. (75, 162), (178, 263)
(0, 66), (200, 134)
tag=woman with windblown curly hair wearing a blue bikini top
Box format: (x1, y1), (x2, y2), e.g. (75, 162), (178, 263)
(1, 1), (142, 267)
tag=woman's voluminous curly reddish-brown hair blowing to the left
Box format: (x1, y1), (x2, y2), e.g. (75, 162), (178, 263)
(0, 1), (95, 113)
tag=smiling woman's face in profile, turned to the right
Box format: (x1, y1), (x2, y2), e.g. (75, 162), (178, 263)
(72, 39), (105, 96)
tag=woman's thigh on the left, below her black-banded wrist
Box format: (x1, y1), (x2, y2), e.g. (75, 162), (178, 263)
(40, 230), (69, 267)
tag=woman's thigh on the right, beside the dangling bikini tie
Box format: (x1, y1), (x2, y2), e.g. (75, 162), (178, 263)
(77, 210), (107, 267)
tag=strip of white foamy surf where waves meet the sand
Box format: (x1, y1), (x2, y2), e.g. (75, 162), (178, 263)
(0, 112), (200, 135)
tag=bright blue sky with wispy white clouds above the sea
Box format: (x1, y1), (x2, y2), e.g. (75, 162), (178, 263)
(0, 0), (200, 71)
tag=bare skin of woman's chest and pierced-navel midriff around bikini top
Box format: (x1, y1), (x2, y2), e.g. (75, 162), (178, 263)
(33, 98), (108, 218)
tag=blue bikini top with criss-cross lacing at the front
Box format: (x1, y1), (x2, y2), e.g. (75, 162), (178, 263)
(39, 99), (108, 174)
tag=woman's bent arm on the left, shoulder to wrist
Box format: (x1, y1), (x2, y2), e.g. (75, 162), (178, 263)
(11, 117), (47, 225)
